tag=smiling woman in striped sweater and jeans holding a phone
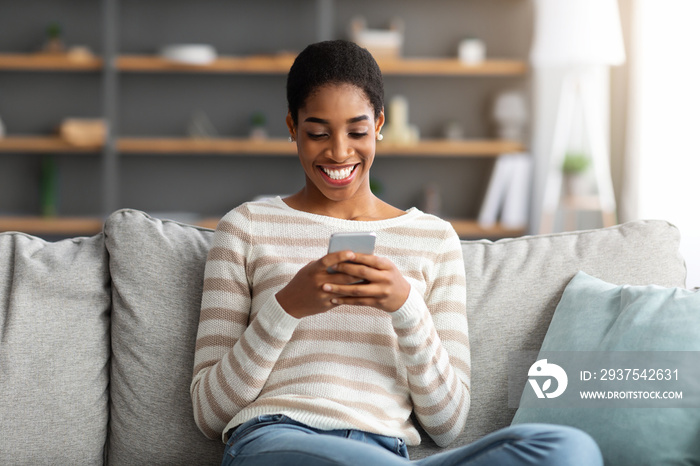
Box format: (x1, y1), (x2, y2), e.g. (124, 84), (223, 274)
(190, 41), (600, 466)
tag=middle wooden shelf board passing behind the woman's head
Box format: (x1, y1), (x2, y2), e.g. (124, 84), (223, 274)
(117, 138), (524, 157)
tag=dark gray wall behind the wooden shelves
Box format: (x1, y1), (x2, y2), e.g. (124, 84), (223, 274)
(0, 0), (532, 217)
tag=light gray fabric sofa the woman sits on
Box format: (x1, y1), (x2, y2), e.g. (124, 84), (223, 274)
(0, 210), (686, 465)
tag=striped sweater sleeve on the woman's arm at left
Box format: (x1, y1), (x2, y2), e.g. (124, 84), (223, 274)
(190, 206), (298, 439)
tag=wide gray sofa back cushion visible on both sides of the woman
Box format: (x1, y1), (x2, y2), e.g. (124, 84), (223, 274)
(105, 210), (685, 465)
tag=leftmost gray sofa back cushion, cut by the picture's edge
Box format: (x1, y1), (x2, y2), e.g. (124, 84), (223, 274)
(0, 233), (110, 465)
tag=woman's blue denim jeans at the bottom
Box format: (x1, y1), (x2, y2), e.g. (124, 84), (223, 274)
(221, 414), (603, 466)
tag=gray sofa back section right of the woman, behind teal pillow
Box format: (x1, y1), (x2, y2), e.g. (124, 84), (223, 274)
(414, 220), (686, 458)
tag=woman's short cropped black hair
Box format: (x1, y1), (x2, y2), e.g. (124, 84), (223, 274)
(287, 40), (384, 125)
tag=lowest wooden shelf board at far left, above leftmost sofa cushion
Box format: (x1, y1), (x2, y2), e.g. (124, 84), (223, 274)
(0, 216), (104, 236)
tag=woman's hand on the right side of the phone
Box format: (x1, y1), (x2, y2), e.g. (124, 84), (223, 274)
(323, 253), (411, 312)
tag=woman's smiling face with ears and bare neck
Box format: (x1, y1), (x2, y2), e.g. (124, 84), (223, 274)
(286, 84), (392, 220)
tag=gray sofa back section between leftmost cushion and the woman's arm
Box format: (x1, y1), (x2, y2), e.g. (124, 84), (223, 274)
(105, 210), (224, 465)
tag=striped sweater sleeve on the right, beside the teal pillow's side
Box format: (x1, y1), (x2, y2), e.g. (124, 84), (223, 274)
(392, 229), (471, 447)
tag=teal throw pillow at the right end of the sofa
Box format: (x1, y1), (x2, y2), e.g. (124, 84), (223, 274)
(513, 272), (700, 466)
